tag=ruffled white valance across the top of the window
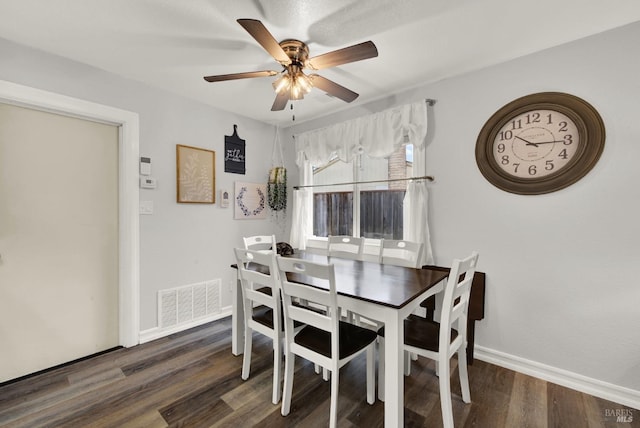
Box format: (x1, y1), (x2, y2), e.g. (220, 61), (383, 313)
(295, 101), (427, 166)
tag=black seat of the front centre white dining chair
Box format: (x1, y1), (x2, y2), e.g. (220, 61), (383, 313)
(294, 322), (377, 359)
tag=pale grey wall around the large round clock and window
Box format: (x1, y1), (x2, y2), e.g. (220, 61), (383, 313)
(283, 23), (640, 407)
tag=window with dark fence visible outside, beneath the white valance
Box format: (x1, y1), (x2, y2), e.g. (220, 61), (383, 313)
(313, 145), (413, 239)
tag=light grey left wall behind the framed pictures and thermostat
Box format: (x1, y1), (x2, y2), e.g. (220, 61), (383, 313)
(0, 39), (284, 331)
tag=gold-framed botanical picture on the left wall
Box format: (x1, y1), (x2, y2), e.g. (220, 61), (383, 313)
(176, 144), (216, 204)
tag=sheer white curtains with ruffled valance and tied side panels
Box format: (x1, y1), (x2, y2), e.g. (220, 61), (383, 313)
(291, 101), (433, 254)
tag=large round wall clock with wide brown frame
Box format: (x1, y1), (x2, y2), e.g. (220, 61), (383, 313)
(476, 92), (605, 195)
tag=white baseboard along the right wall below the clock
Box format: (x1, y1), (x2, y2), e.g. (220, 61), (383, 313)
(474, 345), (640, 409)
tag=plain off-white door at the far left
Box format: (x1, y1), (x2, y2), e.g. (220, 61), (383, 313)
(0, 104), (119, 382)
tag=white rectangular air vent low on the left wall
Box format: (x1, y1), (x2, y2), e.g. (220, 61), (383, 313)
(158, 279), (222, 328)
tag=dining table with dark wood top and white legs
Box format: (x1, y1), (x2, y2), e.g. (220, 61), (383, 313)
(232, 250), (448, 427)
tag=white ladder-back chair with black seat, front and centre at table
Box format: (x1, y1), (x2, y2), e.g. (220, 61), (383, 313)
(277, 256), (377, 428)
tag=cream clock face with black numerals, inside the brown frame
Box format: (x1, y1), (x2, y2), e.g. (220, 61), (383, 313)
(492, 109), (580, 179)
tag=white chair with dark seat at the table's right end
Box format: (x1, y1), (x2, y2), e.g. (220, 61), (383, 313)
(378, 251), (478, 428)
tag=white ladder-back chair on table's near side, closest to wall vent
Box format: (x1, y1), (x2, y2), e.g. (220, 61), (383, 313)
(234, 248), (284, 404)
